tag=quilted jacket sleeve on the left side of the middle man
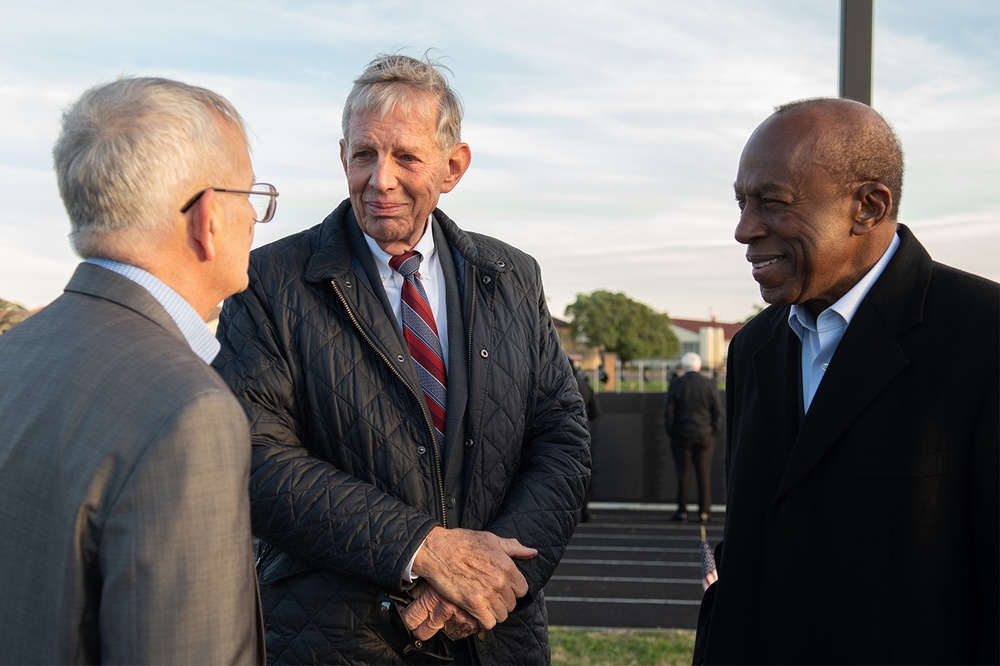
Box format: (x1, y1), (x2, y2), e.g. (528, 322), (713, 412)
(215, 266), (437, 589)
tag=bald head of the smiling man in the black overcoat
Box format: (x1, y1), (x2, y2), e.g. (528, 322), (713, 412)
(733, 99), (903, 314)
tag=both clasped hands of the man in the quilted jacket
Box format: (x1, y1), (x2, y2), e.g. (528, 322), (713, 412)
(401, 527), (538, 640)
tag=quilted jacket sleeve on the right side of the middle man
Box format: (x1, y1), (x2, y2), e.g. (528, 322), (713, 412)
(486, 264), (591, 596)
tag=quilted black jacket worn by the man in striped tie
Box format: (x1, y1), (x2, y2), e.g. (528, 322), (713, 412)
(215, 201), (590, 664)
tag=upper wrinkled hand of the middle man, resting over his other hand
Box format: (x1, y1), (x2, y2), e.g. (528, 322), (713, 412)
(413, 527), (538, 629)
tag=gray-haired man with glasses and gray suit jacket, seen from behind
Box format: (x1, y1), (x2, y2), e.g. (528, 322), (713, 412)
(0, 78), (277, 664)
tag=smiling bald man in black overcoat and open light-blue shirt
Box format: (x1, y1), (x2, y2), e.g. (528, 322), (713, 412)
(694, 99), (1000, 664)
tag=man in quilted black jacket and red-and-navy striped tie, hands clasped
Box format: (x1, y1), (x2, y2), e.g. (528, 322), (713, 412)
(216, 55), (590, 664)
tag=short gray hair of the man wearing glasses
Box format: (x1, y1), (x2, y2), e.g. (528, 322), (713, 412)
(52, 78), (247, 258)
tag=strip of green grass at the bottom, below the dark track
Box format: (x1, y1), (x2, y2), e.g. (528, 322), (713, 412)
(549, 627), (694, 666)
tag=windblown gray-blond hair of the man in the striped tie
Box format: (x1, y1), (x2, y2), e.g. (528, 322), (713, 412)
(341, 54), (462, 150)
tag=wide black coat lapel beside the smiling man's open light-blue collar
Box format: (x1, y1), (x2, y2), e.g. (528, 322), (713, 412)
(776, 225), (931, 499)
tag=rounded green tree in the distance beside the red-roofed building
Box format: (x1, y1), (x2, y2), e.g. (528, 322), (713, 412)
(565, 290), (680, 361)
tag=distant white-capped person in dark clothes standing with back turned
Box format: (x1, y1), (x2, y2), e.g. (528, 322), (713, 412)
(663, 352), (722, 523)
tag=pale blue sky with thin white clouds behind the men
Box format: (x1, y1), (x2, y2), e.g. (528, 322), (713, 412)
(0, 0), (1000, 321)
